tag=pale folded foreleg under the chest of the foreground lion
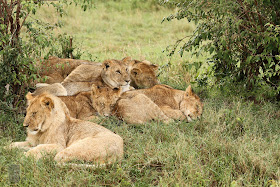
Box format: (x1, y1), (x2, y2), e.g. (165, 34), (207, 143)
(25, 144), (64, 160)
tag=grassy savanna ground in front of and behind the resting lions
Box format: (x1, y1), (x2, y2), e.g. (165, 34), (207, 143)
(0, 1), (280, 186)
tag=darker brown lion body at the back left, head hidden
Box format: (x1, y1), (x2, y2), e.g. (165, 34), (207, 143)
(38, 56), (100, 84)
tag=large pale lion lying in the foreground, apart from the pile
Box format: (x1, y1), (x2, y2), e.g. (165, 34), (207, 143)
(10, 94), (123, 164)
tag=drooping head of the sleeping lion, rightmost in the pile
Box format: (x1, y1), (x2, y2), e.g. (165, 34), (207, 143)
(180, 85), (203, 121)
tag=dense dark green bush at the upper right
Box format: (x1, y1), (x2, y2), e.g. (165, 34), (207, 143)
(166, 0), (280, 97)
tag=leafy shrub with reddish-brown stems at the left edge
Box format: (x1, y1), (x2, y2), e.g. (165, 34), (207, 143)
(0, 0), (91, 107)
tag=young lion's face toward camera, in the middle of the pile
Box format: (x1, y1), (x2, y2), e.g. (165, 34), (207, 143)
(92, 84), (122, 116)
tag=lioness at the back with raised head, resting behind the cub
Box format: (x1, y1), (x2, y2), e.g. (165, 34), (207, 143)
(62, 60), (130, 95)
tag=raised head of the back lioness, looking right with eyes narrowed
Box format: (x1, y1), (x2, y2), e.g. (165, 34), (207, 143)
(101, 59), (130, 89)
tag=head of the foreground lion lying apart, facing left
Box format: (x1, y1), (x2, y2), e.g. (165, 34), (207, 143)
(23, 92), (69, 135)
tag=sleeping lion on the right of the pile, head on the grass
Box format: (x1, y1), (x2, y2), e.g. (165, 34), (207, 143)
(93, 85), (203, 124)
